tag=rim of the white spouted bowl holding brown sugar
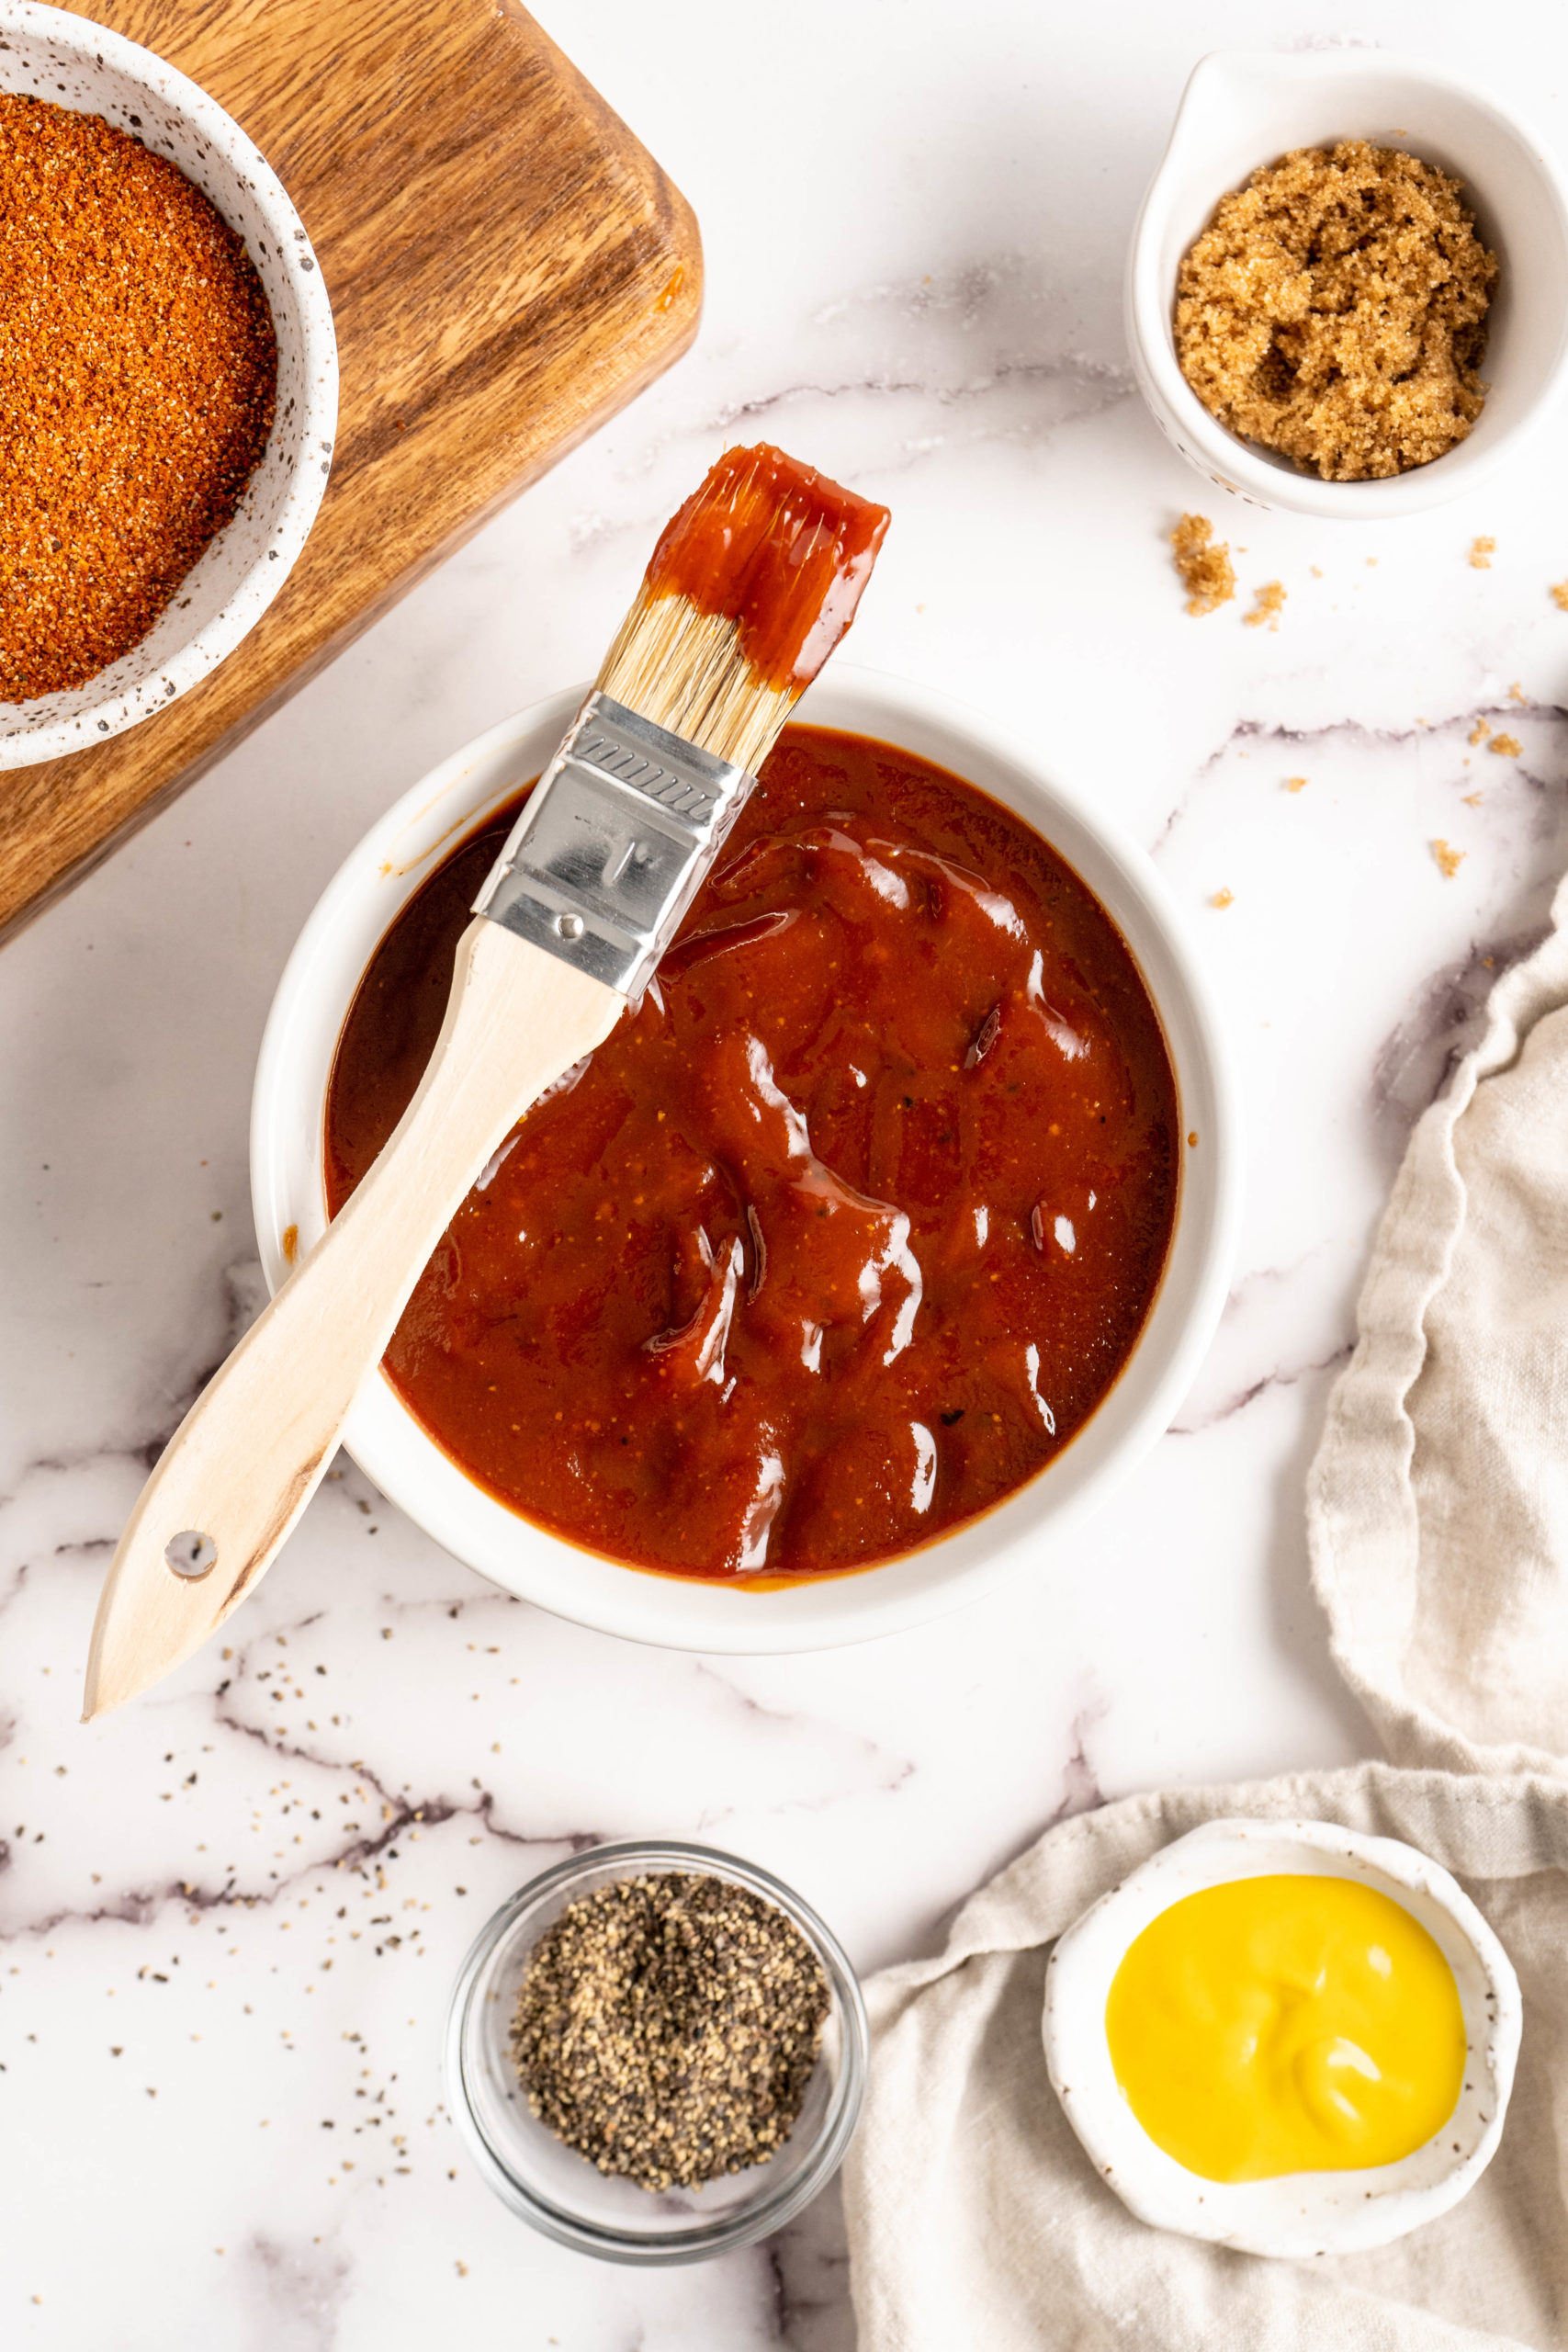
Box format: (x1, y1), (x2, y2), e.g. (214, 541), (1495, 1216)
(1123, 47), (1568, 522)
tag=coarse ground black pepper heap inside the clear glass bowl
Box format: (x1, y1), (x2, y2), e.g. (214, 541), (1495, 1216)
(513, 1870), (828, 2189)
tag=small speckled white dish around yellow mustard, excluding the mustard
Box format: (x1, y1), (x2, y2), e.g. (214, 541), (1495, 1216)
(1043, 1820), (1521, 2258)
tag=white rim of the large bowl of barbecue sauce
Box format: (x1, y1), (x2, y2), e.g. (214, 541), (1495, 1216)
(252, 663), (1241, 1656)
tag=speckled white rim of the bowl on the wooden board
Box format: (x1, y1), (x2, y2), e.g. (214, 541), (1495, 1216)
(0, 0), (339, 769)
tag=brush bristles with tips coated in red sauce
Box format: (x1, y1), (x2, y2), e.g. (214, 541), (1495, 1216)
(597, 445), (888, 774)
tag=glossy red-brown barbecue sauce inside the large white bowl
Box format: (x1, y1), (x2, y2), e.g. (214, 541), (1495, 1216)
(327, 727), (1178, 1578)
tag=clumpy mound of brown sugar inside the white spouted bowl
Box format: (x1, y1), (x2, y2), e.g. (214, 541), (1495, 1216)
(1176, 139), (1497, 482)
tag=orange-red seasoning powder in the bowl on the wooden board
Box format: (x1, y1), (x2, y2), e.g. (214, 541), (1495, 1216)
(0, 94), (277, 701)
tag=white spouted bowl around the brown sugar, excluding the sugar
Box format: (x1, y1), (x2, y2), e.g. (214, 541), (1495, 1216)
(1126, 50), (1568, 522)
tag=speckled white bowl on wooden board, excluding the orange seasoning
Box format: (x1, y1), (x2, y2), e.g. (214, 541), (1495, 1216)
(0, 0), (339, 767)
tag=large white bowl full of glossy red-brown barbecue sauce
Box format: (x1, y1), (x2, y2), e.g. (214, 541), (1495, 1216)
(252, 663), (1239, 1654)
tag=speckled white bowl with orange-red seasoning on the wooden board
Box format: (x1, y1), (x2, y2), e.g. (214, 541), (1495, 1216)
(0, 0), (339, 767)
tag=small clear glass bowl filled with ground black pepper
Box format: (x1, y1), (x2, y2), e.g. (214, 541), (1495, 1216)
(446, 1839), (870, 2263)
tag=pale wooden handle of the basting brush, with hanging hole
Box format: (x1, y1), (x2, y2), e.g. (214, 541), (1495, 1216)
(83, 915), (626, 1722)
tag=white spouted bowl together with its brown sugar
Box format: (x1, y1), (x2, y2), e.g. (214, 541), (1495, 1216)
(1126, 50), (1568, 522)
